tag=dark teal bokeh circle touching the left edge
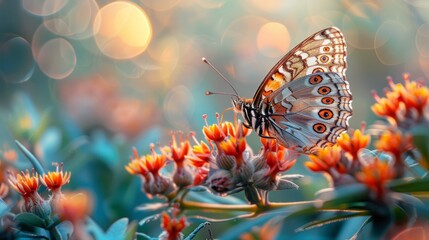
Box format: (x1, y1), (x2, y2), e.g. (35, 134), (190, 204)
(0, 37), (35, 83)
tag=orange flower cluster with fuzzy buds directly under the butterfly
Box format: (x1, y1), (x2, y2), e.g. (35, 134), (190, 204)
(125, 115), (301, 202)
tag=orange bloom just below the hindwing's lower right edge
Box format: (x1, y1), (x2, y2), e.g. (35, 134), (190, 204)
(337, 127), (371, 161)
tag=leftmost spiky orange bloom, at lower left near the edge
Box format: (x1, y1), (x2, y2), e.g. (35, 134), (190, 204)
(9, 169), (40, 198)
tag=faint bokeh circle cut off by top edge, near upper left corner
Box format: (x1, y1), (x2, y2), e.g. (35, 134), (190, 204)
(21, 0), (67, 16)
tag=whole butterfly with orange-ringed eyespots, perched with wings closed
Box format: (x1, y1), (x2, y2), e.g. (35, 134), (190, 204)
(232, 27), (352, 153)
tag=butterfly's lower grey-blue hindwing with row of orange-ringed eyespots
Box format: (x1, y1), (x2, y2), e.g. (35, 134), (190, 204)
(264, 72), (352, 152)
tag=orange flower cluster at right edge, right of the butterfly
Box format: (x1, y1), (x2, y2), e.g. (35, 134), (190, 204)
(305, 74), (429, 201)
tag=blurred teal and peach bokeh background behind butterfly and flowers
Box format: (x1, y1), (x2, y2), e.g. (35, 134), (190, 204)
(0, 0), (429, 238)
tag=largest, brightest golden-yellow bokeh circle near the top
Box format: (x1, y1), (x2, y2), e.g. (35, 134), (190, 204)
(94, 1), (152, 59)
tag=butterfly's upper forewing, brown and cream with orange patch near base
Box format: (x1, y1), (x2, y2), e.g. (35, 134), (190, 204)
(253, 27), (347, 106)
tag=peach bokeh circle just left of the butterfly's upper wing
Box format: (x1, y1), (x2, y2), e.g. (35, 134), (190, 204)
(257, 22), (290, 58)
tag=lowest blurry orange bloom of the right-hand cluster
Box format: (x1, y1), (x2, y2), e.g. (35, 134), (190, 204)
(356, 158), (395, 201)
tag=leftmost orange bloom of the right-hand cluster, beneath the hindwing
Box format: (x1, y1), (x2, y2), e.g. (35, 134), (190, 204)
(304, 145), (348, 174)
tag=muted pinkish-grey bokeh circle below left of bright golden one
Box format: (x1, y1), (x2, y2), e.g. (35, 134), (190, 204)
(36, 38), (76, 80)
